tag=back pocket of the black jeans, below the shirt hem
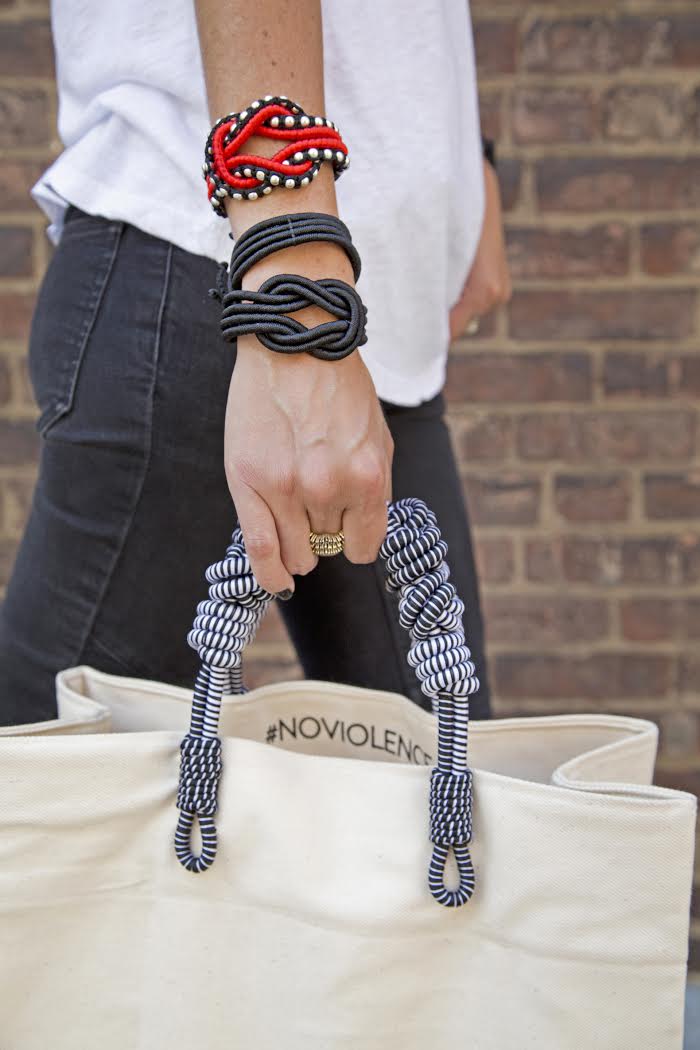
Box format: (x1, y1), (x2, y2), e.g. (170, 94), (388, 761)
(28, 212), (124, 437)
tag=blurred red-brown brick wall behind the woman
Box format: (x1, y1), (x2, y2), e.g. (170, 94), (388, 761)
(0, 0), (700, 966)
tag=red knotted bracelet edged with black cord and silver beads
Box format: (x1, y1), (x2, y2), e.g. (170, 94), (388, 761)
(204, 95), (349, 217)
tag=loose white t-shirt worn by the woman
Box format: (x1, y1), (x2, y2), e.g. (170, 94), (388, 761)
(33, 0), (484, 404)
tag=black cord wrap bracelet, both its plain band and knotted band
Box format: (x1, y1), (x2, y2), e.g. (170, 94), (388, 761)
(210, 212), (367, 361)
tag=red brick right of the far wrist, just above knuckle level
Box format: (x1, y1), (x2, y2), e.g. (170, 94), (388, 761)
(507, 223), (630, 280)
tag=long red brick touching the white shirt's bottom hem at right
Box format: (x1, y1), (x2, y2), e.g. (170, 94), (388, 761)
(447, 353), (592, 404)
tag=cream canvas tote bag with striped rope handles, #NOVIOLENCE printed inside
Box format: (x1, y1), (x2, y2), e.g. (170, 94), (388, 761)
(0, 501), (695, 1050)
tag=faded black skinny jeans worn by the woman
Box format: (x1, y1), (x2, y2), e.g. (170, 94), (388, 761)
(0, 208), (489, 725)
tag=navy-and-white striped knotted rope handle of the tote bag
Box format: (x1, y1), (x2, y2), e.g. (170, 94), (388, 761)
(175, 499), (479, 907)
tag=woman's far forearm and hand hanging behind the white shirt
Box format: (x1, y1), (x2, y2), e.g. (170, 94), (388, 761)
(449, 161), (511, 339)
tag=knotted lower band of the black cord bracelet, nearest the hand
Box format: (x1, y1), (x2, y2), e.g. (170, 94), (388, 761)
(221, 273), (367, 361)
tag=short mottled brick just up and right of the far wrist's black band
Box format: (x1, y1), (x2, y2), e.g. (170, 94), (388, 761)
(510, 84), (597, 146)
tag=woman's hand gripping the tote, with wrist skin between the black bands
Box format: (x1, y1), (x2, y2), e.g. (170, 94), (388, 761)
(225, 244), (394, 593)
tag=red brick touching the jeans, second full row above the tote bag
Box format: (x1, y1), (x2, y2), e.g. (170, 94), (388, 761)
(484, 594), (610, 646)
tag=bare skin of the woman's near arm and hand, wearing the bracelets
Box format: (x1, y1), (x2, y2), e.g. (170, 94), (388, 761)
(196, 0), (394, 593)
